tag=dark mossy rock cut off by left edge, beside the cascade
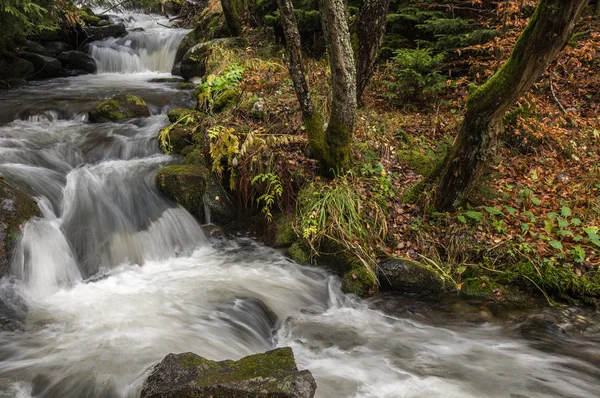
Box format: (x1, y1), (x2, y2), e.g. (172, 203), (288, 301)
(0, 178), (40, 278)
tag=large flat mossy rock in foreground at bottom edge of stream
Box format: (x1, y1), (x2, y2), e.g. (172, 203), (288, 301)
(141, 347), (317, 398)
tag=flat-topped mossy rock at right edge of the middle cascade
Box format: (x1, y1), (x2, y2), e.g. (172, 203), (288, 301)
(156, 165), (211, 219)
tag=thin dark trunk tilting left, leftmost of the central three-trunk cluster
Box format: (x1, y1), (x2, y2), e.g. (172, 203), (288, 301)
(277, 0), (325, 162)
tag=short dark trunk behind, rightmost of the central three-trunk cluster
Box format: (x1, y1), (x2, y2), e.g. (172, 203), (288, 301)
(356, 0), (390, 106)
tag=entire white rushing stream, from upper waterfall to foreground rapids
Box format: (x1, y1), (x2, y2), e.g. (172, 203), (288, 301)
(0, 11), (600, 398)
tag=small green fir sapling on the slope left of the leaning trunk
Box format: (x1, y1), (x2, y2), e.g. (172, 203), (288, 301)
(387, 48), (446, 103)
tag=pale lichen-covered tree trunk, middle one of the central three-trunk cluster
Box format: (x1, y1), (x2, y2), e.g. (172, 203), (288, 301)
(319, 0), (356, 174)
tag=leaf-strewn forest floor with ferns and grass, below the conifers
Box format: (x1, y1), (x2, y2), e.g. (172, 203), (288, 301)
(165, 3), (600, 305)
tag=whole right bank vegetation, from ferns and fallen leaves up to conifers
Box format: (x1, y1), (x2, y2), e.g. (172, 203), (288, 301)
(144, 1), (600, 305)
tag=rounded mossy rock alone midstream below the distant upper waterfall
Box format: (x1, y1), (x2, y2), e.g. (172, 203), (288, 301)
(89, 94), (150, 123)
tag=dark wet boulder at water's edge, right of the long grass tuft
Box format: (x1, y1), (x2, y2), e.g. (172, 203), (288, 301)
(379, 259), (444, 294)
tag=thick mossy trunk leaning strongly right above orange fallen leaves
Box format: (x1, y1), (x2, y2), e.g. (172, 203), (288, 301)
(434, 0), (587, 211)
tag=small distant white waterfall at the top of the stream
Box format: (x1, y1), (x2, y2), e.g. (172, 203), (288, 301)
(90, 14), (188, 73)
